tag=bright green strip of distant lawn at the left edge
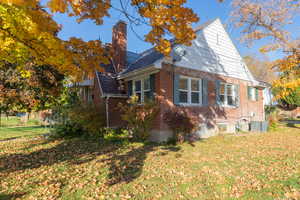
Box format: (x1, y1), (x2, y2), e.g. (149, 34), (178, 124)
(0, 126), (49, 140)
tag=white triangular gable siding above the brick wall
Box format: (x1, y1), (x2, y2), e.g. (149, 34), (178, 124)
(171, 19), (255, 81)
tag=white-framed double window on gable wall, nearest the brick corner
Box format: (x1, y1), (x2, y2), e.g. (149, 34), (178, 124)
(178, 76), (202, 104)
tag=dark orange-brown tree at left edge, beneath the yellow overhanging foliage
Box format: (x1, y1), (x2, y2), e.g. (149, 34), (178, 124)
(0, 64), (64, 112)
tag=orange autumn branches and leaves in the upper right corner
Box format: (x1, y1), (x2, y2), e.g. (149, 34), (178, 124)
(232, 0), (300, 99)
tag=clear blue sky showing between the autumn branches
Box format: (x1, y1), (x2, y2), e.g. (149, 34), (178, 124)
(44, 0), (300, 60)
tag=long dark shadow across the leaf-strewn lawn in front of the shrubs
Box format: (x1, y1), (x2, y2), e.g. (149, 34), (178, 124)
(0, 139), (180, 185)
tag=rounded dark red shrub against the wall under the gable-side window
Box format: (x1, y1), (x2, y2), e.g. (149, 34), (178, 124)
(164, 108), (198, 143)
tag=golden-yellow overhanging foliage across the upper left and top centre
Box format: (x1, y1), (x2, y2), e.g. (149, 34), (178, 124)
(0, 0), (202, 79)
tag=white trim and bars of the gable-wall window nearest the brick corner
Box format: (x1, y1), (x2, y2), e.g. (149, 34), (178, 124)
(178, 75), (202, 106)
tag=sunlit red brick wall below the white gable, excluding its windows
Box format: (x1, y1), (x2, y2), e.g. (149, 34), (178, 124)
(155, 64), (264, 130)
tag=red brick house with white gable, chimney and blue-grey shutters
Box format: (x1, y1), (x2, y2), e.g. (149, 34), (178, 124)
(80, 19), (265, 141)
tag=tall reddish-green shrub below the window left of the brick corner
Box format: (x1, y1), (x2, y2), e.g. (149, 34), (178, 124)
(118, 96), (159, 141)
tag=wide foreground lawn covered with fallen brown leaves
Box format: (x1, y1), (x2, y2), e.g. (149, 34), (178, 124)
(0, 127), (300, 200)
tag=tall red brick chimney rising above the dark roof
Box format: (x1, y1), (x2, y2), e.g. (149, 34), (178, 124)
(112, 21), (127, 73)
